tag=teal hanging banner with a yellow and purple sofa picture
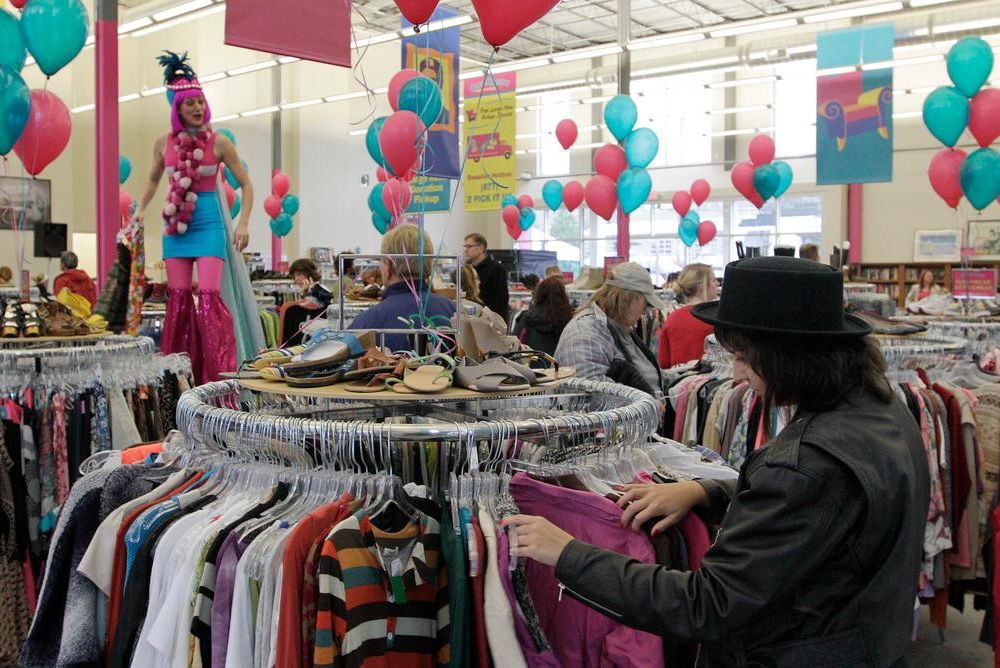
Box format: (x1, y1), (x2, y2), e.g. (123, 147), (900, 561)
(816, 24), (895, 185)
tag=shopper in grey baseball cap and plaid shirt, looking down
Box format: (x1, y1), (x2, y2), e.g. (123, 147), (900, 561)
(556, 262), (667, 396)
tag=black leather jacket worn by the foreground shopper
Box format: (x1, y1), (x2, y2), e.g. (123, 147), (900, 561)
(556, 393), (929, 668)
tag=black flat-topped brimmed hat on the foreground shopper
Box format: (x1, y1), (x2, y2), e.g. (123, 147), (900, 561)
(691, 257), (872, 337)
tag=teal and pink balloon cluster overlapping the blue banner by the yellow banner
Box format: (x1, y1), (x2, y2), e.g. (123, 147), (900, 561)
(365, 69), (443, 234)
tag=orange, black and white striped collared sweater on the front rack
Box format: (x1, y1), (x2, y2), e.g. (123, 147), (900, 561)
(314, 511), (450, 668)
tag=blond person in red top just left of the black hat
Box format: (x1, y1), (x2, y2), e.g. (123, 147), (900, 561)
(657, 264), (719, 369)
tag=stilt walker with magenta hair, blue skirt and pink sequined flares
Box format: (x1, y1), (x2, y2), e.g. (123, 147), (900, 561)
(135, 51), (263, 384)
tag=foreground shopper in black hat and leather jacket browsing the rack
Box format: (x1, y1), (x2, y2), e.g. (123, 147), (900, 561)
(508, 257), (929, 667)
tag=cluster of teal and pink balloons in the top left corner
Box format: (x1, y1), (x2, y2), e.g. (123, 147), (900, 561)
(0, 0), (90, 176)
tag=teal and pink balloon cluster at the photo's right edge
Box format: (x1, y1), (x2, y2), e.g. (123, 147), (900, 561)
(924, 37), (1000, 211)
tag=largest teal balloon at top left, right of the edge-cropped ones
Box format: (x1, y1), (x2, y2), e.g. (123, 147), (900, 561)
(21, 0), (90, 76)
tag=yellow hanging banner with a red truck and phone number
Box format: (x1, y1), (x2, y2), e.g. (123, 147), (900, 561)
(463, 72), (517, 211)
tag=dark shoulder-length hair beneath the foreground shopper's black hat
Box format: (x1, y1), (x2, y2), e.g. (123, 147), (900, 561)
(715, 326), (892, 435)
